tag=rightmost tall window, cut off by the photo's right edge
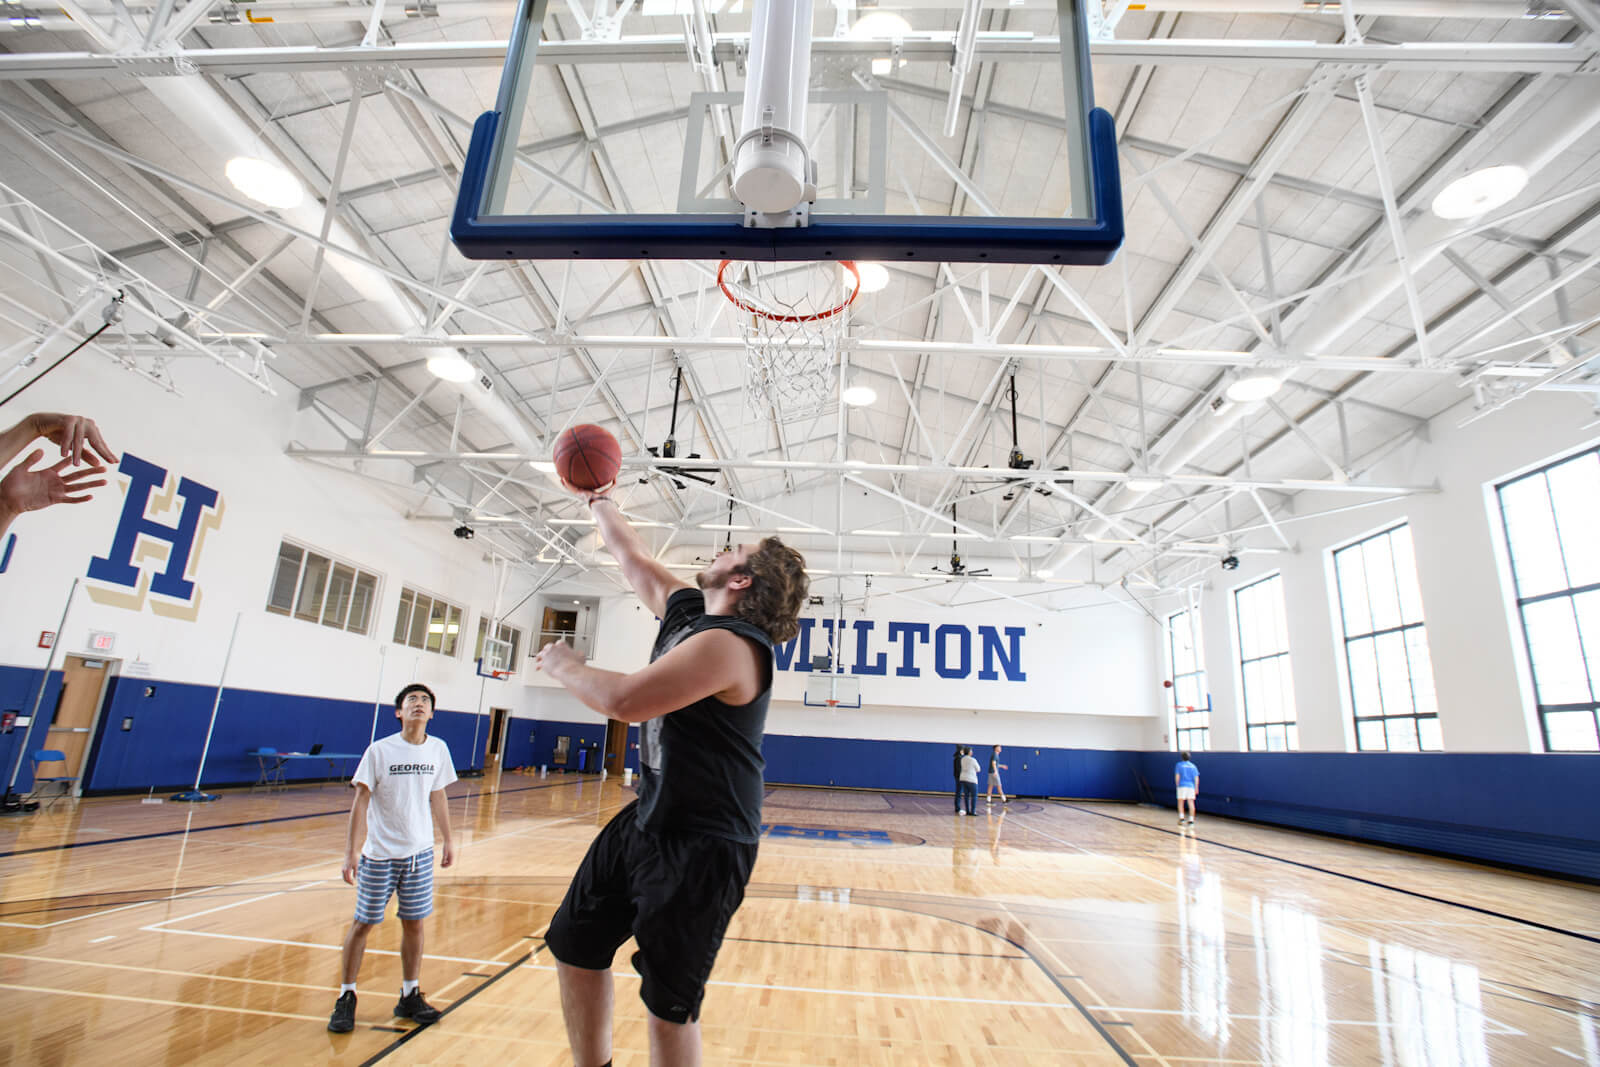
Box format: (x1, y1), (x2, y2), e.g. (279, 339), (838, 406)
(1496, 450), (1600, 752)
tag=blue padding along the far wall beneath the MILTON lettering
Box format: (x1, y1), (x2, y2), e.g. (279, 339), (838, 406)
(762, 734), (1139, 800)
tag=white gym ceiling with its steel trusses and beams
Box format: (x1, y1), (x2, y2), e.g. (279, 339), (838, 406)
(0, 0), (1600, 611)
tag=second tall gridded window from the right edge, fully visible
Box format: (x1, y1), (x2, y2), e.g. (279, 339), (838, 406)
(1333, 526), (1443, 752)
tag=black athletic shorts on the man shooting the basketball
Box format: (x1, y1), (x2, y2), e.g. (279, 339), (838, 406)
(544, 801), (757, 1022)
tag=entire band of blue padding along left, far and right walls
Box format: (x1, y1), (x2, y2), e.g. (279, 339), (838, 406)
(0, 655), (1600, 880)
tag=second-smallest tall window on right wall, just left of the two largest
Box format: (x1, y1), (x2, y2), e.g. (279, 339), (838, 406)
(1234, 574), (1299, 752)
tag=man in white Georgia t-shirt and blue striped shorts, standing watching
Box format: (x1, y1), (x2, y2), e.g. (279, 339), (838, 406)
(328, 685), (456, 1033)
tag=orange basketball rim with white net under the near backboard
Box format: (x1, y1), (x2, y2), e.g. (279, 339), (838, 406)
(717, 259), (861, 422)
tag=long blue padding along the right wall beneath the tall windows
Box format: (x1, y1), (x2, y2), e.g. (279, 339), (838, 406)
(1142, 752), (1600, 880)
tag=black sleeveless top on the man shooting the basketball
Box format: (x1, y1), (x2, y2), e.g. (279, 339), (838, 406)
(637, 589), (773, 841)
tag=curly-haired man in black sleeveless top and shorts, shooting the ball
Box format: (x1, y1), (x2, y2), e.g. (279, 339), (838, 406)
(536, 490), (808, 1067)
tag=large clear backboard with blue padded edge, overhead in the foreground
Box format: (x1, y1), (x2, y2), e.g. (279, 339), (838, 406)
(451, 0), (1123, 266)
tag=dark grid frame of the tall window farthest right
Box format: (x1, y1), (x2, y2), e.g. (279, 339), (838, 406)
(1485, 443), (1600, 755)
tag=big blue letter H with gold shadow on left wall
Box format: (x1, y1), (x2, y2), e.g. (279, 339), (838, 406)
(88, 453), (222, 622)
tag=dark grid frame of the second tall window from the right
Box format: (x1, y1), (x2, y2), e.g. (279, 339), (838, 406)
(1328, 518), (1445, 752)
